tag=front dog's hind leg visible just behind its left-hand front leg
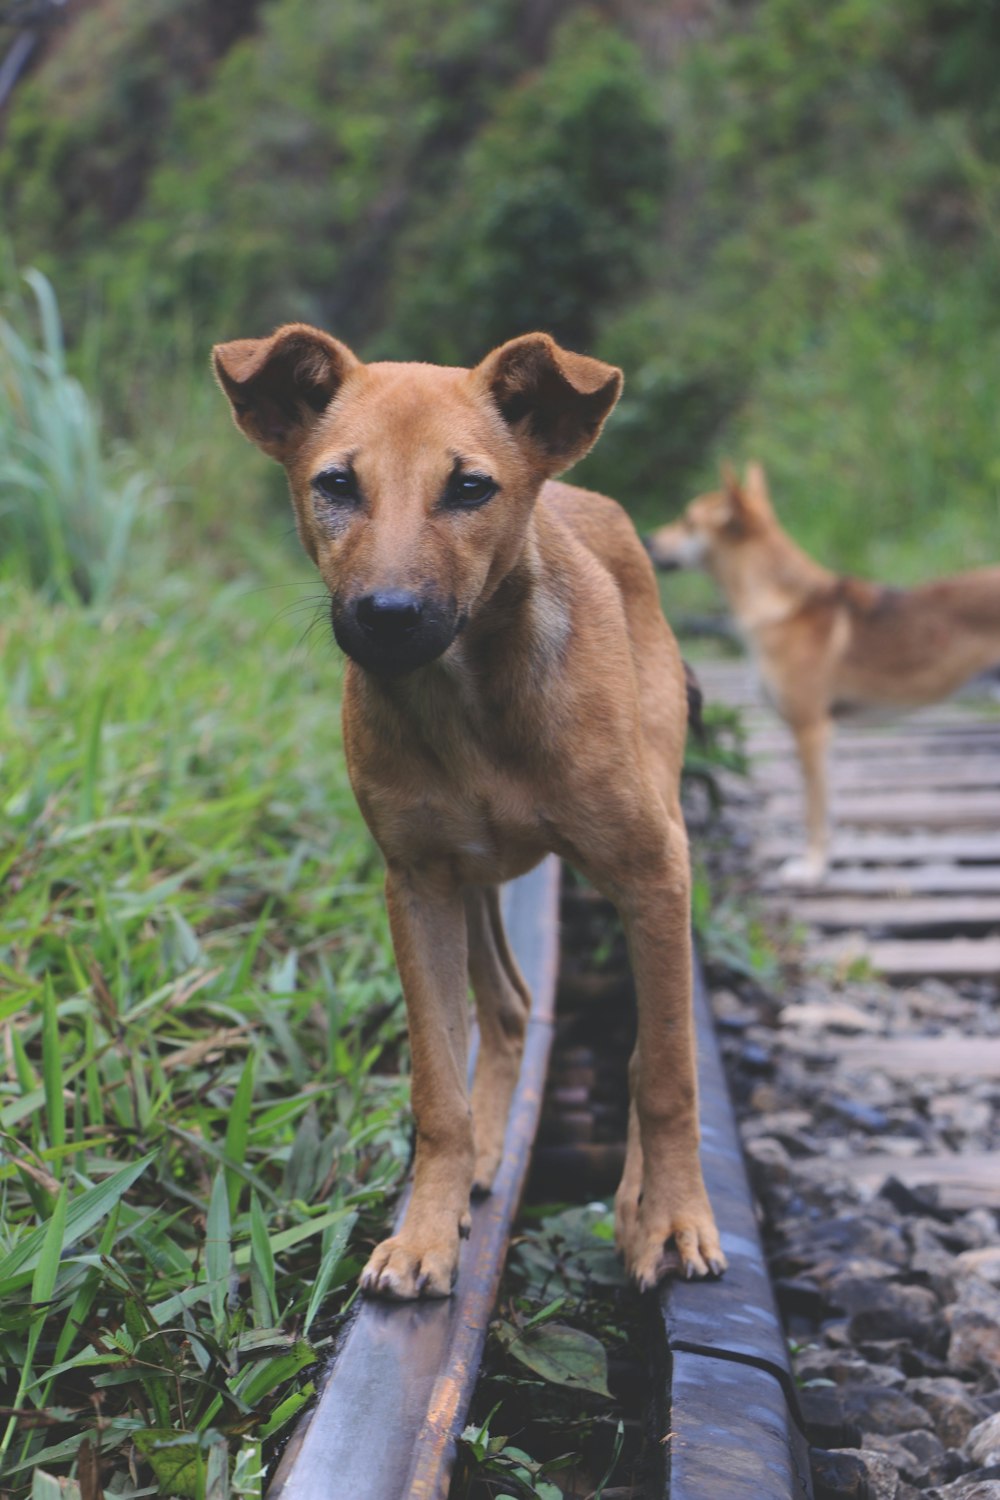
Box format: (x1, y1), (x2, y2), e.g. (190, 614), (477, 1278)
(465, 885), (531, 1193)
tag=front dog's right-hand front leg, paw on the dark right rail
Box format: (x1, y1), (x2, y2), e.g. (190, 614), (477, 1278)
(615, 822), (726, 1290)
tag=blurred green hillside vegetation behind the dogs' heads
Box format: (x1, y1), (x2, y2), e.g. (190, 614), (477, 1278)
(0, 0), (1000, 576)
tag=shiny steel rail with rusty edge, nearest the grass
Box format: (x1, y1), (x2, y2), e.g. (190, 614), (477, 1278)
(267, 858), (559, 1500)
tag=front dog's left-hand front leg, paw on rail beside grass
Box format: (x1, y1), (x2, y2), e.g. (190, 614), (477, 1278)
(361, 869), (474, 1299)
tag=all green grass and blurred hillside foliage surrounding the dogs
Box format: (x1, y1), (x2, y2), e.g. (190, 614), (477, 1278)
(0, 0), (1000, 1500)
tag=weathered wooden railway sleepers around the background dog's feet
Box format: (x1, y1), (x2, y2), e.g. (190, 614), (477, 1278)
(699, 663), (1000, 1208)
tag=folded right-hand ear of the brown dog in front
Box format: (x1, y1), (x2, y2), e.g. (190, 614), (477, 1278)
(475, 333), (622, 474)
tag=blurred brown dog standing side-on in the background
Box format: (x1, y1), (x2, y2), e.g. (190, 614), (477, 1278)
(646, 464), (1000, 884)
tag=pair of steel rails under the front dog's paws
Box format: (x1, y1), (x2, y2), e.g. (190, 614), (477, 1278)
(268, 861), (811, 1500)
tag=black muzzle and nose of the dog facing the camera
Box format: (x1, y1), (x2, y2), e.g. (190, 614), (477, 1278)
(330, 588), (459, 677)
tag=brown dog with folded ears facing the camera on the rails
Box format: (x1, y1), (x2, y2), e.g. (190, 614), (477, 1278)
(214, 324), (724, 1298)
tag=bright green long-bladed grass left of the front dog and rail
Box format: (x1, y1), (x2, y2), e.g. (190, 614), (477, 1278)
(0, 581), (409, 1497)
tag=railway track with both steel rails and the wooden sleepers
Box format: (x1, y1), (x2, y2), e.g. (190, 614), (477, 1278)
(268, 666), (1000, 1500)
